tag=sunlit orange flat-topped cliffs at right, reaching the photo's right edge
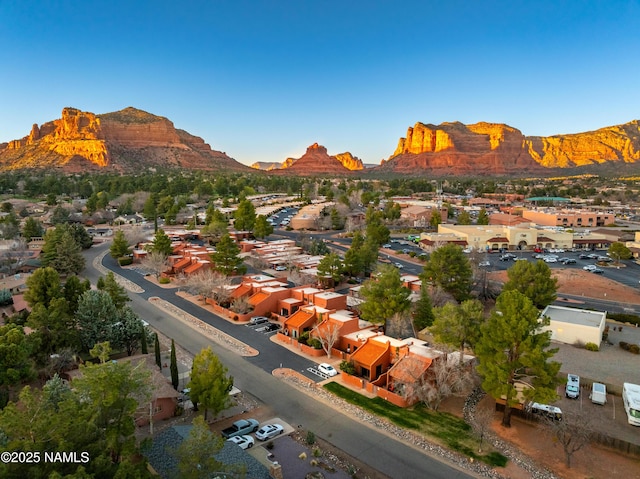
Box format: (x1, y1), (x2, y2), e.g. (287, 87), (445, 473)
(376, 120), (640, 175)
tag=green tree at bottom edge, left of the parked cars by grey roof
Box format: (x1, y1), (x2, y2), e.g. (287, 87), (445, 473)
(174, 416), (232, 479)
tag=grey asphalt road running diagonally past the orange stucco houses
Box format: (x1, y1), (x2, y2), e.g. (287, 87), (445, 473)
(86, 246), (475, 479)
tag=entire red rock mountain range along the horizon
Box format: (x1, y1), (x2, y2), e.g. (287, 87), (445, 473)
(0, 107), (640, 176)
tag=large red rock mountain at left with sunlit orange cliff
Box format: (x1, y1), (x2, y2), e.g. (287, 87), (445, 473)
(0, 107), (248, 172)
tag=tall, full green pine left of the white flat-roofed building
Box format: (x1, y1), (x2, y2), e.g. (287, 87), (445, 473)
(475, 290), (560, 427)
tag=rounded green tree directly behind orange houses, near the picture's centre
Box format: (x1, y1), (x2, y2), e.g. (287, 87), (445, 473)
(360, 265), (411, 324)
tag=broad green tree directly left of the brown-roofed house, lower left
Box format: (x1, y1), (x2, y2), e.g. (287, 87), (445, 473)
(73, 361), (151, 463)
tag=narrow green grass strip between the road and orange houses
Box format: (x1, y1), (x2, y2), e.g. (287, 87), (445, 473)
(324, 382), (507, 467)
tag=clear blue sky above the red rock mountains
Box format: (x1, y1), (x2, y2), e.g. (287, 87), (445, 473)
(0, 0), (640, 164)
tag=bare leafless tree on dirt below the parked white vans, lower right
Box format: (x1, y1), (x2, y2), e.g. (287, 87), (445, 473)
(546, 406), (594, 468)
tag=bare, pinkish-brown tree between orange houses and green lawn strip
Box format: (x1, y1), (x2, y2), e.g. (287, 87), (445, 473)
(402, 353), (474, 411)
